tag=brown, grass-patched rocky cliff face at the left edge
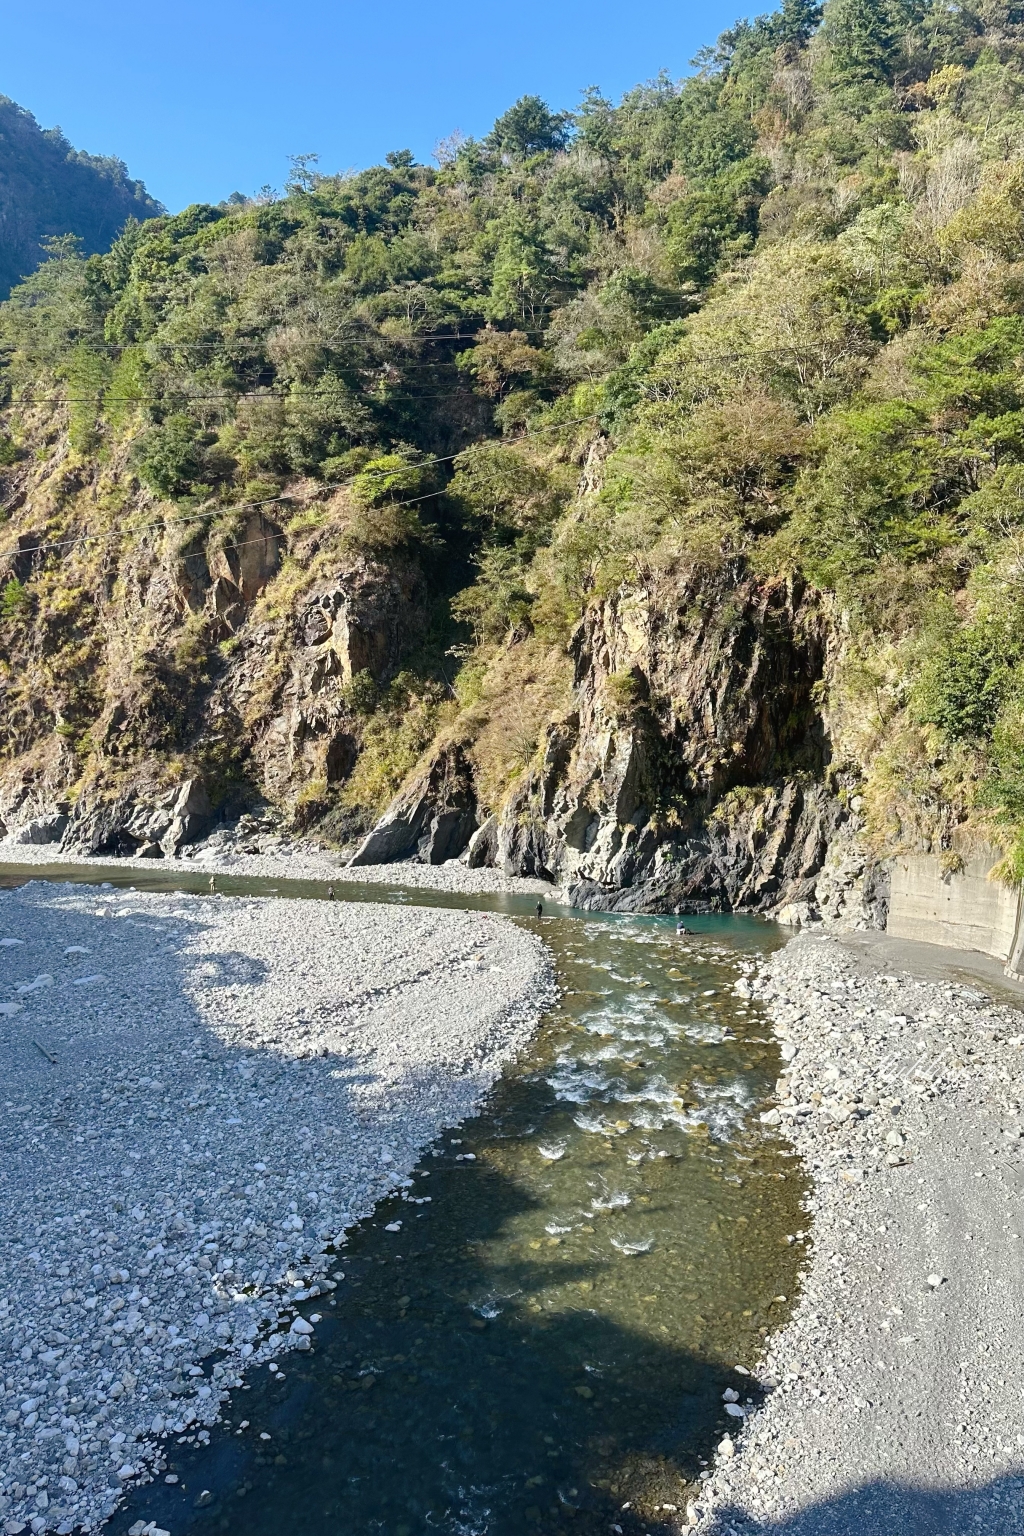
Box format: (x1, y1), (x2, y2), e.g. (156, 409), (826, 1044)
(0, 433), (427, 857)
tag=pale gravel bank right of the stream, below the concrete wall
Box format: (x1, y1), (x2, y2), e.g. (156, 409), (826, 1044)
(688, 937), (1024, 1536)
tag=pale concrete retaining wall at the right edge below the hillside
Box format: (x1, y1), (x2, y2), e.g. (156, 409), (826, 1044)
(886, 848), (1019, 962)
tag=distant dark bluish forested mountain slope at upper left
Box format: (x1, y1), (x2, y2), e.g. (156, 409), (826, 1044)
(0, 95), (163, 298)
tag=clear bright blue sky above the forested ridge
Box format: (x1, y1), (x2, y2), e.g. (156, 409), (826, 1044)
(0, 0), (758, 210)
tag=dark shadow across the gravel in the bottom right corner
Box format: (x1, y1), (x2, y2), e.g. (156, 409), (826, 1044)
(711, 1473), (1024, 1536)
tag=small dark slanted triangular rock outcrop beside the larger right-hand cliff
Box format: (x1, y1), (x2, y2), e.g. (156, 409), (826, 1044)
(352, 743), (476, 865)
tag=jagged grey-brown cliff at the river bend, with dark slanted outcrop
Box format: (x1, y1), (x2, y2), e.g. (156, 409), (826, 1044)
(361, 562), (886, 925)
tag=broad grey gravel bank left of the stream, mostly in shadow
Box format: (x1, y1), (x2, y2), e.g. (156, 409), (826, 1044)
(0, 882), (553, 1536)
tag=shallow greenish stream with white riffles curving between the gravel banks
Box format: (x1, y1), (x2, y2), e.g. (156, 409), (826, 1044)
(0, 865), (804, 1536)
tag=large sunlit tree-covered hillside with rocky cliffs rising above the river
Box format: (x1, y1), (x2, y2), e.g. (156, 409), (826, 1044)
(0, 0), (1024, 908)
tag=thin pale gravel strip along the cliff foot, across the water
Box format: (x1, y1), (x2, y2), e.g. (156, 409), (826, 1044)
(0, 840), (557, 900)
